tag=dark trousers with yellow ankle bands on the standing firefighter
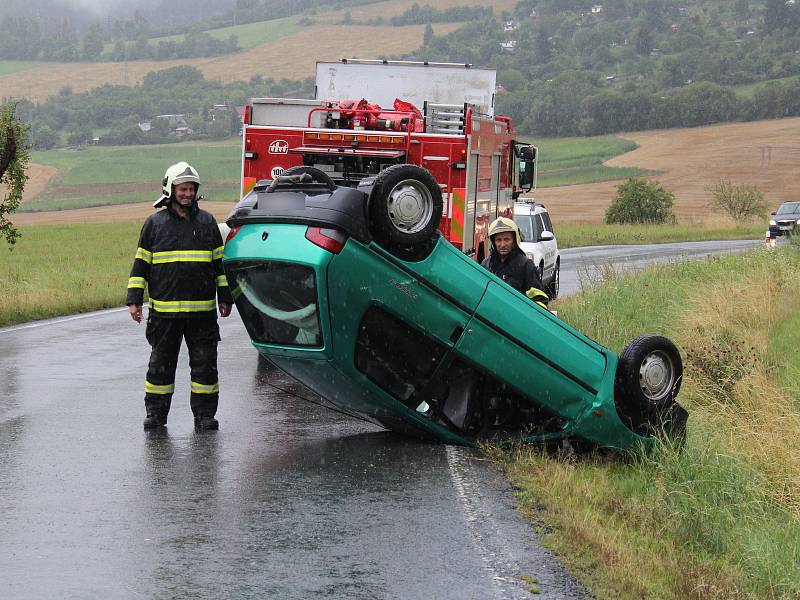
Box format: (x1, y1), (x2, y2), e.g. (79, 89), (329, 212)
(144, 314), (220, 423)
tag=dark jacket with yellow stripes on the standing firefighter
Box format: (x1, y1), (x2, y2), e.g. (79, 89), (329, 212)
(125, 204), (233, 318)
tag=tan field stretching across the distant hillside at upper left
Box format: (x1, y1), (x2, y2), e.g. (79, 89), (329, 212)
(0, 0), (515, 102)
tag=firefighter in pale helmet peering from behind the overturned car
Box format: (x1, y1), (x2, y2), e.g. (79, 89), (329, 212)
(481, 217), (550, 308)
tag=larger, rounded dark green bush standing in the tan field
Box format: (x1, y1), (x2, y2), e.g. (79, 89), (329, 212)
(606, 177), (675, 224)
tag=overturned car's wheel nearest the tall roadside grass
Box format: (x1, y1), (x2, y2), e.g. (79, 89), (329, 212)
(614, 334), (686, 440)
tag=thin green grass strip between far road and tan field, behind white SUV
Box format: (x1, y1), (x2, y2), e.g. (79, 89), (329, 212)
(556, 223), (765, 248)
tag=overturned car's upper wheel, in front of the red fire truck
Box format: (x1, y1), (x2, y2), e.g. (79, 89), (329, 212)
(369, 165), (442, 247)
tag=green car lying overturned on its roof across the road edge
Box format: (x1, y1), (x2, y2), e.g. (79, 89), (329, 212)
(223, 165), (687, 448)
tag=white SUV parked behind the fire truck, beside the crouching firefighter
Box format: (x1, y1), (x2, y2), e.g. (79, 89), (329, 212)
(514, 199), (561, 298)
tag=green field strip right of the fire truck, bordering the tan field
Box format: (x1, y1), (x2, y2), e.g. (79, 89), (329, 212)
(525, 135), (653, 187)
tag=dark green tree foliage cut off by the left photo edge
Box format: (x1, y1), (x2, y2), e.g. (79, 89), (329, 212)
(0, 104), (30, 246)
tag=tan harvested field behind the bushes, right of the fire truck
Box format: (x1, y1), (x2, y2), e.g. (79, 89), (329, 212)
(536, 118), (800, 225)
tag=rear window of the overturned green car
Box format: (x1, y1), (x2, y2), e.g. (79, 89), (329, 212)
(225, 261), (322, 348)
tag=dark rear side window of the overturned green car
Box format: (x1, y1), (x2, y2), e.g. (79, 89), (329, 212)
(355, 306), (447, 408)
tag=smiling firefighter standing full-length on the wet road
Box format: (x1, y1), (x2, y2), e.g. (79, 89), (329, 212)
(126, 162), (233, 429)
